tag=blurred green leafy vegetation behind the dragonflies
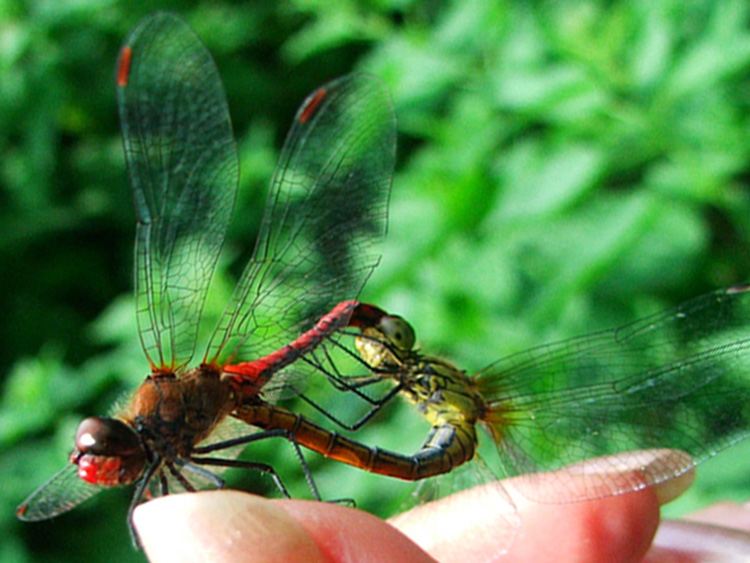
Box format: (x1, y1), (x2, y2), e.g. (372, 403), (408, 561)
(0, 0), (750, 561)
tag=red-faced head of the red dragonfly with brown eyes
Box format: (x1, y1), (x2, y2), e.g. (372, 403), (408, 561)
(70, 417), (146, 487)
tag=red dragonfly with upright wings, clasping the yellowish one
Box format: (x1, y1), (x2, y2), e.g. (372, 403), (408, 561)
(17, 13), (396, 532)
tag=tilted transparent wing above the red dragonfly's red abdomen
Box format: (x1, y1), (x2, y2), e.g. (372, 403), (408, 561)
(207, 74), (396, 364)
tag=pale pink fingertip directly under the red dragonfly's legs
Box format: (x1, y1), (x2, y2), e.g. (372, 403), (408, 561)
(133, 491), (433, 563)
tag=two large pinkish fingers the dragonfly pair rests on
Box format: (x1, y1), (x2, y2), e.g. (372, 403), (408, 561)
(134, 450), (704, 563)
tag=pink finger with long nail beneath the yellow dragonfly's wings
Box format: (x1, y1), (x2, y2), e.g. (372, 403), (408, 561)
(391, 450), (692, 563)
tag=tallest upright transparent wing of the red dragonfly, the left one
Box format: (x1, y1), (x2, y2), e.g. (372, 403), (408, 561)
(117, 14), (239, 371)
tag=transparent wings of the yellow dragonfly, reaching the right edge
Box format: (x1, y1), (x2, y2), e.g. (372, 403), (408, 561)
(475, 286), (750, 500)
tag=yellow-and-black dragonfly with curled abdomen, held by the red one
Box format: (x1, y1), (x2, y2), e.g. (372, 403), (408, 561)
(242, 290), (750, 502)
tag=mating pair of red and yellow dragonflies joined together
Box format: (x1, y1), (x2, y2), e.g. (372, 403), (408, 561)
(18, 14), (750, 540)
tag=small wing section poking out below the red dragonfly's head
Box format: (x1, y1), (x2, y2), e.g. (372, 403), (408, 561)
(16, 464), (102, 522)
